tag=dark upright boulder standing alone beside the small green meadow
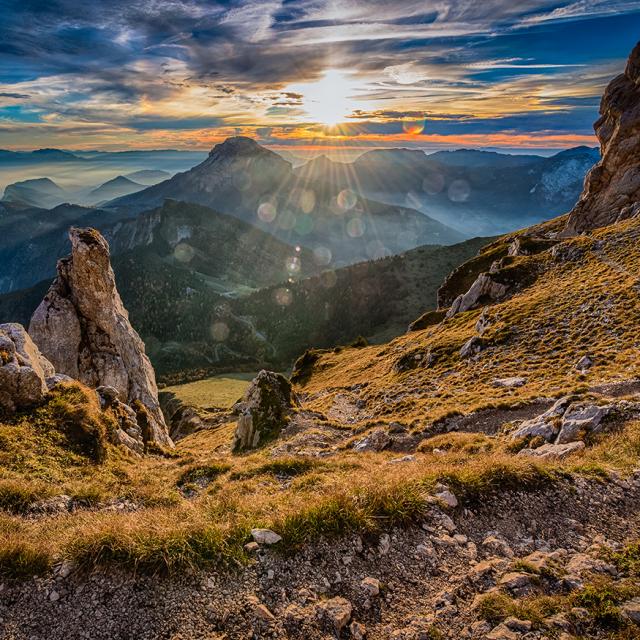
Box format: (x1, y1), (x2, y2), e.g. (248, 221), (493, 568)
(232, 370), (299, 452)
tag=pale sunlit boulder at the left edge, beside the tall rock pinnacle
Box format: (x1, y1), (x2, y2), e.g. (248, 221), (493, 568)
(0, 323), (55, 414)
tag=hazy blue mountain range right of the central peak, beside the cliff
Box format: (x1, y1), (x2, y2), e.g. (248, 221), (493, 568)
(296, 147), (600, 236)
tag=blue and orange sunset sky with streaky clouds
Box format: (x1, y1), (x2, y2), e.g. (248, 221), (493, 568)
(0, 0), (640, 153)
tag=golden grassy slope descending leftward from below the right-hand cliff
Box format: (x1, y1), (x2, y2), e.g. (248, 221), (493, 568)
(304, 220), (640, 426)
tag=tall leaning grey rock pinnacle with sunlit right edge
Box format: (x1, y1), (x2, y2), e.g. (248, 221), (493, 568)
(29, 228), (173, 446)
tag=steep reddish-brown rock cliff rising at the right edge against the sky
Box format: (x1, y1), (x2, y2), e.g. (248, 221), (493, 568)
(564, 43), (640, 235)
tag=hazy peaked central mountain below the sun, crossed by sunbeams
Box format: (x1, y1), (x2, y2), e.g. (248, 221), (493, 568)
(105, 137), (464, 265)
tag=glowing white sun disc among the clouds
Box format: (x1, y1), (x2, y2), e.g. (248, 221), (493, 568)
(291, 69), (356, 126)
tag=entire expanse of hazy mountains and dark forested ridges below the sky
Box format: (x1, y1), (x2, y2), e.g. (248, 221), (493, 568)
(0, 137), (597, 375)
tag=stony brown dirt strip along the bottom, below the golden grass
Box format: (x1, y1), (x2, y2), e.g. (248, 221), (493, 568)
(0, 470), (640, 640)
